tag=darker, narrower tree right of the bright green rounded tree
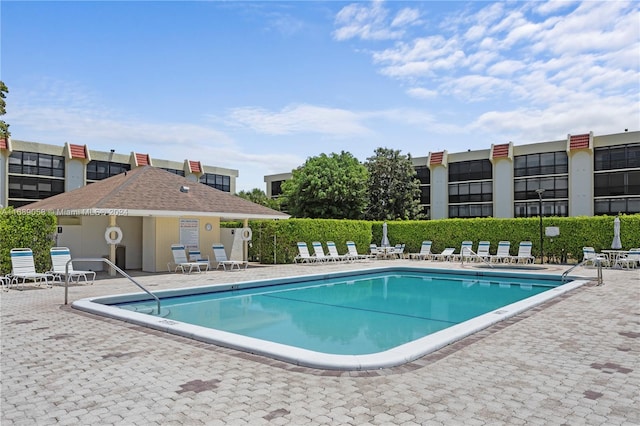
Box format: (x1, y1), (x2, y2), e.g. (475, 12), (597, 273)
(365, 148), (421, 220)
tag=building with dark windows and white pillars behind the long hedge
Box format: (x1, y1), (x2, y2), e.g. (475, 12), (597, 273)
(264, 131), (640, 219)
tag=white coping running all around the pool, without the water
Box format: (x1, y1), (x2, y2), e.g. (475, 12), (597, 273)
(72, 266), (589, 371)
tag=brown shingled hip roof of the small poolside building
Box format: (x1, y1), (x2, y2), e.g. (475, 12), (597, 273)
(21, 166), (289, 219)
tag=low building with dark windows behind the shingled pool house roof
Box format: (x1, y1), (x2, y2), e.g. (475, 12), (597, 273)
(0, 139), (238, 207)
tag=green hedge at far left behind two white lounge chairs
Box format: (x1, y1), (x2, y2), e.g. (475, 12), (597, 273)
(0, 207), (56, 275)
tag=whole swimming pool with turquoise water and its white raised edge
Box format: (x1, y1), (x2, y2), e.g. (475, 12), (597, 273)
(73, 267), (584, 370)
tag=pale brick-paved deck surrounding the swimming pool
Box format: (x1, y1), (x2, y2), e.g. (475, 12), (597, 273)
(0, 260), (640, 426)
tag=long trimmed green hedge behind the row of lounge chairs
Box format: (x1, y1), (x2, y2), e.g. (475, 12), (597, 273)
(242, 214), (640, 264)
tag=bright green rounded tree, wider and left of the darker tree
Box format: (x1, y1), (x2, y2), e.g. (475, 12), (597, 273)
(281, 151), (369, 219)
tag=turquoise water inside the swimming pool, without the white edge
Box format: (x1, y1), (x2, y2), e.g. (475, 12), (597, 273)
(116, 271), (560, 355)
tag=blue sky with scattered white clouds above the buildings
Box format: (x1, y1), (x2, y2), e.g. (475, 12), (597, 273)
(0, 0), (640, 190)
